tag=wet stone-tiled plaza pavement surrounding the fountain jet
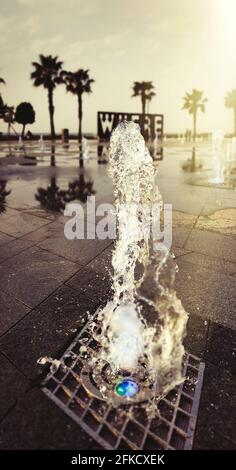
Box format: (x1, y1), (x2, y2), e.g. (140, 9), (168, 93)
(0, 141), (236, 449)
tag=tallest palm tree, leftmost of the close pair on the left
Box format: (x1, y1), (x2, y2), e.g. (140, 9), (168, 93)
(30, 54), (63, 139)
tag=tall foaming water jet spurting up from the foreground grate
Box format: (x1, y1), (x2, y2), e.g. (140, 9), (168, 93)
(93, 121), (187, 398)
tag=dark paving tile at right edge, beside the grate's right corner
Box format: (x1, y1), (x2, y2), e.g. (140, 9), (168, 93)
(205, 322), (236, 376)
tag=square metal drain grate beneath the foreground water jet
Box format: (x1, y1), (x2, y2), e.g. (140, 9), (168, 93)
(43, 323), (204, 450)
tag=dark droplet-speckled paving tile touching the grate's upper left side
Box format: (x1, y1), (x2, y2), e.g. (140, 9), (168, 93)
(0, 286), (99, 379)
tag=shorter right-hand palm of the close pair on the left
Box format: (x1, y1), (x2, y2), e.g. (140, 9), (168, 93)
(61, 69), (95, 142)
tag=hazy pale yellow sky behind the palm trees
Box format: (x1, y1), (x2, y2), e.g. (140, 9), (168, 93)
(0, 0), (236, 132)
